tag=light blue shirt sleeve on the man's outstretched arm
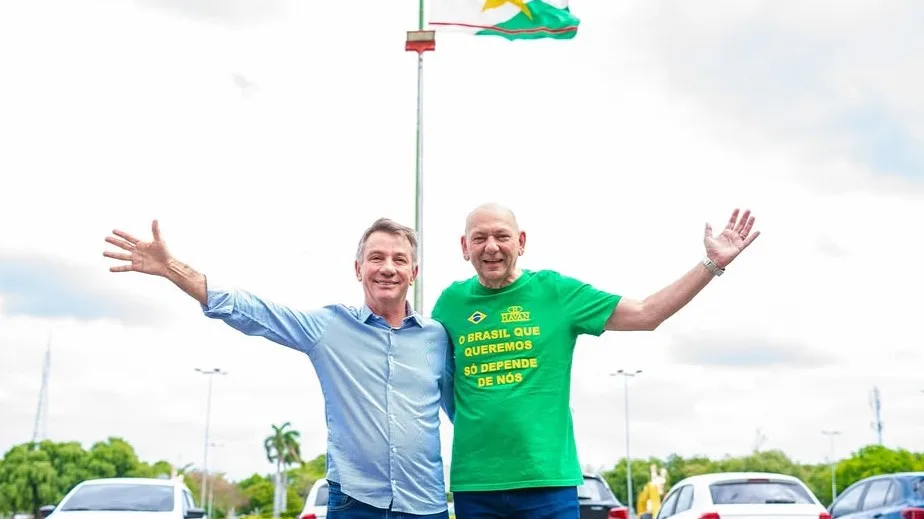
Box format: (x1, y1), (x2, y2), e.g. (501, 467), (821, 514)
(200, 282), (334, 354)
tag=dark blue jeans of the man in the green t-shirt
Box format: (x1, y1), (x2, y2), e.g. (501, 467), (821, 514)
(452, 487), (581, 519)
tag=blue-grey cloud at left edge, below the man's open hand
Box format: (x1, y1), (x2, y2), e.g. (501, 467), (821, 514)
(0, 251), (178, 325)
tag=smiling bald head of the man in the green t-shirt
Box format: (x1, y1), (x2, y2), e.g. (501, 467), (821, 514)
(462, 204), (526, 288)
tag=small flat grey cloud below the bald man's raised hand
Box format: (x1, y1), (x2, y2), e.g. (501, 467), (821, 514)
(669, 330), (835, 369)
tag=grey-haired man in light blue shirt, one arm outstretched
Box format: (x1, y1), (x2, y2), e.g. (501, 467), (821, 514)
(103, 218), (454, 519)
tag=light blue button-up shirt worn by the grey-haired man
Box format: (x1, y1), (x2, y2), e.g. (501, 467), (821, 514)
(202, 284), (454, 515)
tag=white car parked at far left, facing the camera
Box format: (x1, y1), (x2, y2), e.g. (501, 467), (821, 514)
(48, 478), (205, 519)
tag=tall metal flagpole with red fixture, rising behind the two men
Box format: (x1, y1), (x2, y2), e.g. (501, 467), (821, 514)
(404, 0), (436, 312)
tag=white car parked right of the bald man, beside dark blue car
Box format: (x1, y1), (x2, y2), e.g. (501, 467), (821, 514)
(657, 472), (831, 519)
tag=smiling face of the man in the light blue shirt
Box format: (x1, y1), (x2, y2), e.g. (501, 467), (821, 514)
(355, 231), (417, 314)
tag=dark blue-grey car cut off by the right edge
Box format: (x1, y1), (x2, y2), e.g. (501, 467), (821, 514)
(828, 472), (924, 519)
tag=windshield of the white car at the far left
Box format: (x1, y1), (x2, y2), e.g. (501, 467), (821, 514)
(60, 483), (173, 512)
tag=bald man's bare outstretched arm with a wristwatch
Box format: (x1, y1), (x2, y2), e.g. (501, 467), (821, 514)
(605, 209), (760, 331)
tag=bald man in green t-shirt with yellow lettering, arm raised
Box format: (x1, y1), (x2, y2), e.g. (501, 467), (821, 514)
(433, 204), (760, 519)
